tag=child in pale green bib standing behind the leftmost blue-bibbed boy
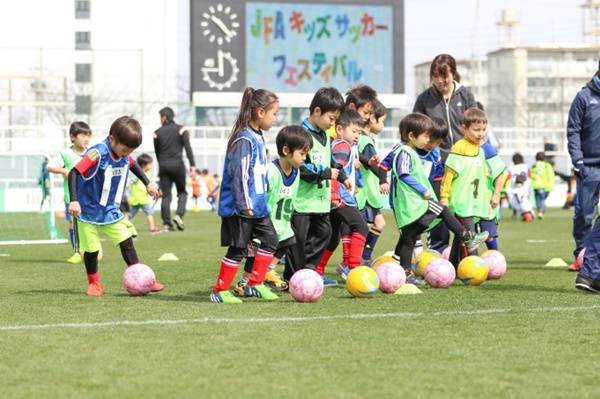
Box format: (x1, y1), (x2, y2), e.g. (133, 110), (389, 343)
(46, 122), (92, 264)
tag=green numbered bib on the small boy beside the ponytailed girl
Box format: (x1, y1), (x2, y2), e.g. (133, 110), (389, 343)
(267, 162), (300, 242)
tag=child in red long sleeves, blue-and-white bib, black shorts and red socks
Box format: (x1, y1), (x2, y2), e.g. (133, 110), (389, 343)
(316, 109), (378, 278)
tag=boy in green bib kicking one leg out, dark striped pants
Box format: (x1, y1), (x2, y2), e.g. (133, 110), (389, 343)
(392, 112), (488, 273)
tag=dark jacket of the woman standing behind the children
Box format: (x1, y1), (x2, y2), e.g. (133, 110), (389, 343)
(413, 81), (477, 160)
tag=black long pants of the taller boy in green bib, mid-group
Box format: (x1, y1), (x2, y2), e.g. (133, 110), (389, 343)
(283, 212), (331, 281)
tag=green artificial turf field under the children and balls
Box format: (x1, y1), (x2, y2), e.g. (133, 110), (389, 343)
(0, 209), (600, 399)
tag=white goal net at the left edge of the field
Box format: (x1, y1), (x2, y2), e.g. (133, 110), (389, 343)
(0, 153), (68, 245)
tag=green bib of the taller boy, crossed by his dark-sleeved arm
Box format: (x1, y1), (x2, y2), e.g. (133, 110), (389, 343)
(294, 135), (331, 213)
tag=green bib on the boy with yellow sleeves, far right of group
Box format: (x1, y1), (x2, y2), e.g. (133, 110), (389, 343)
(446, 148), (489, 219)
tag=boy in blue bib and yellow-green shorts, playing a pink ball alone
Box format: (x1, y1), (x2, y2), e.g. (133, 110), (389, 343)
(69, 116), (164, 296)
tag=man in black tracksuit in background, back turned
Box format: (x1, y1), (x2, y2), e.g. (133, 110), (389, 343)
(154, 107), (196, 231)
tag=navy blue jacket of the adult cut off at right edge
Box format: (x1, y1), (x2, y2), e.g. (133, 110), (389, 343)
(567, 81), (600, 165)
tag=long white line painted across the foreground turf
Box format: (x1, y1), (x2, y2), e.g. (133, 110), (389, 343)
(0, 305), (600, 331)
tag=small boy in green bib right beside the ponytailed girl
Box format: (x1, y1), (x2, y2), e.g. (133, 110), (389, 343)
(233, 125), (312, 297)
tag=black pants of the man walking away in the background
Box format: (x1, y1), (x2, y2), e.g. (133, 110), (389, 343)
(158, 162), (187, 226)
